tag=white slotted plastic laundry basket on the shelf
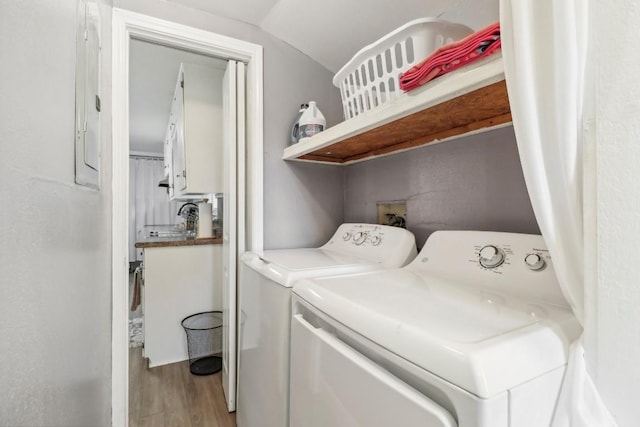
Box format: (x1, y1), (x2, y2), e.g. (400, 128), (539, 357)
(333, 18), (473, 120)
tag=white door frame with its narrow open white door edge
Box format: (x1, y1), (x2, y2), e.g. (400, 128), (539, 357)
(112, 9), (263, 426)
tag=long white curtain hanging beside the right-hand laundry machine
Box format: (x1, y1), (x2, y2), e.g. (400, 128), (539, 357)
(500, 0), (615, 427)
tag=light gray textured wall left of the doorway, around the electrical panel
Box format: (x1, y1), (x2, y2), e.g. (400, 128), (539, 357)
(0, 0), (111, 426)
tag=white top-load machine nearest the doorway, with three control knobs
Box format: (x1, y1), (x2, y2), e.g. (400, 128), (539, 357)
(236, 224), (417, 427)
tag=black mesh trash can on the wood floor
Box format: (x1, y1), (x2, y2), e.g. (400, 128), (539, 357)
(182, 311), (222, 375)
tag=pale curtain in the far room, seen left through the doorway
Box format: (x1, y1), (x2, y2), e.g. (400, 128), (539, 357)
(129, 157), (181, 261)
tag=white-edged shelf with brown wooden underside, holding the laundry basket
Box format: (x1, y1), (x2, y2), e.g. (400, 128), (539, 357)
(282, 53), (511, 165)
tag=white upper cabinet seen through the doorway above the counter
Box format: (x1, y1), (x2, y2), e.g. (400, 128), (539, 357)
(165, 63), (223, 199)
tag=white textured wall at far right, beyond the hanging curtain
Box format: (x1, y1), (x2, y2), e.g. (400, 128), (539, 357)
(585, 0), (640, 427)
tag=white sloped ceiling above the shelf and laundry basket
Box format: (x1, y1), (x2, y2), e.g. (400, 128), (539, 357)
(165, 0), (498, 73)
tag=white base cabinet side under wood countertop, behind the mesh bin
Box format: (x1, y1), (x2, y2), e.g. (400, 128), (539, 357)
(143, 245), (222, 367)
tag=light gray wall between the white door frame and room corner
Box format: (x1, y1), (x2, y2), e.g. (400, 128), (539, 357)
(114, 0), (343, 248)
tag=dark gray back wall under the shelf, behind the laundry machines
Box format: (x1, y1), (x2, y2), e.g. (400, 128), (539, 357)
(345, 127), (539, 247)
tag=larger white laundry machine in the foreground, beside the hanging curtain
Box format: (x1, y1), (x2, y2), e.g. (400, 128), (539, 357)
(290, 231), (581, 427)
